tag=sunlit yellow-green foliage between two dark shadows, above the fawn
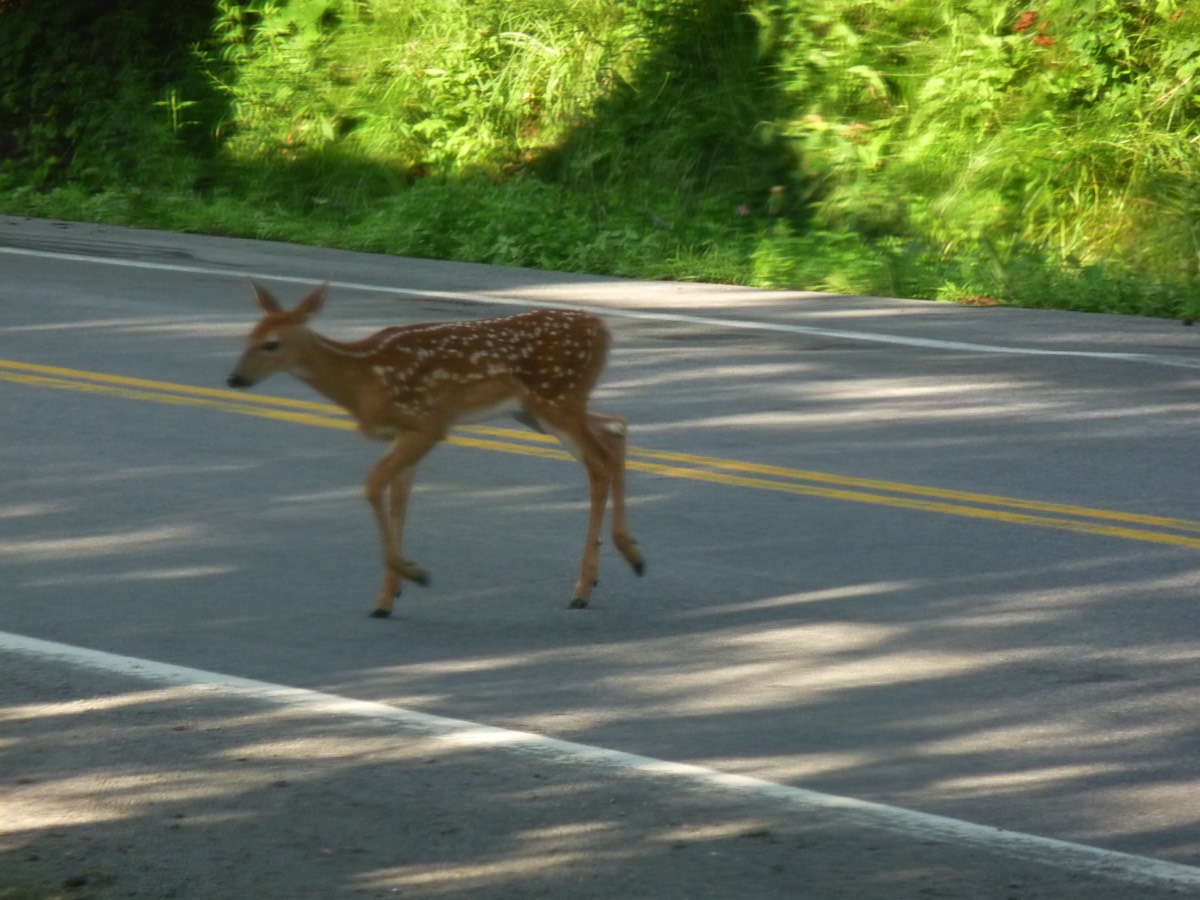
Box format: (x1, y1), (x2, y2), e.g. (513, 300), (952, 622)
(216, 0), (628, 175)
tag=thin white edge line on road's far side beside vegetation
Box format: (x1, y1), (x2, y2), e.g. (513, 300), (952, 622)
(0, 247), (1200, 368)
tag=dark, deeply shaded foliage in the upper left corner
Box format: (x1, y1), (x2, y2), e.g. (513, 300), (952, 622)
(0, 0), (218, 190)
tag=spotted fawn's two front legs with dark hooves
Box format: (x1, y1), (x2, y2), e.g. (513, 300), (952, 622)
(366, 439), (441, 619)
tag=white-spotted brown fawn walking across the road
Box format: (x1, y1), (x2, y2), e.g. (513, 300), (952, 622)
(228, 284), (644, 618)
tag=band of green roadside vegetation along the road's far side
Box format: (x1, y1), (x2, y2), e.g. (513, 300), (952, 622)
(0, 0), (1200, 318)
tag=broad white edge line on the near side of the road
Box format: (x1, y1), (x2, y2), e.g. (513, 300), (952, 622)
(0, 631), (1200, 887)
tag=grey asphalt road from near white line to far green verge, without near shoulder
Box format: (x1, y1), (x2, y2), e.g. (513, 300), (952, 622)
(0, 214), (1200, 896)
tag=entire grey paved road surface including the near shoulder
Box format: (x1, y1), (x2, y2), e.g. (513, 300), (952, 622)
(0, 218), (1200, 898)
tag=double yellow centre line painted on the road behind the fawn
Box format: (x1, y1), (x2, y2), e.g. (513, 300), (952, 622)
(7, 360), (1200, 550)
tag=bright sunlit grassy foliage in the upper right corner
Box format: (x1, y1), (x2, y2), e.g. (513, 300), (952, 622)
(769, 0), (1200, 281)
